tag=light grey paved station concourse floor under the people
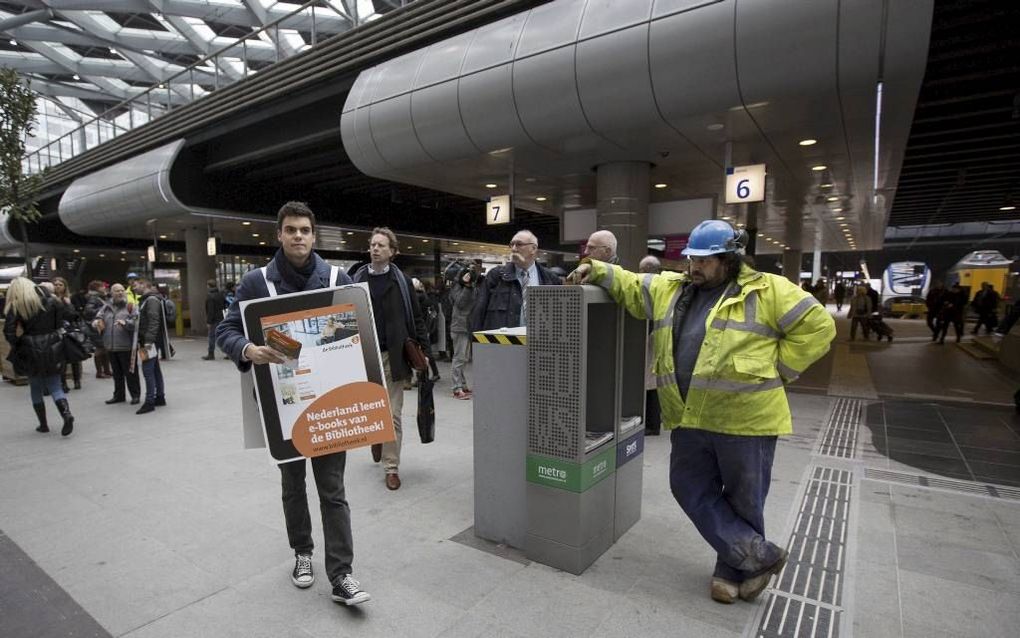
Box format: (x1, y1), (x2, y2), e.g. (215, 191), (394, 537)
(0, 322), (1020, 637)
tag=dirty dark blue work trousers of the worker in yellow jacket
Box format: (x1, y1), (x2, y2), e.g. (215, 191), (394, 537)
(669, 428), (780, 583)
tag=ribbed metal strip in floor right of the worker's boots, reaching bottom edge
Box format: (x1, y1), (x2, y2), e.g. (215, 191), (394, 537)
(757, 467), (854, 638)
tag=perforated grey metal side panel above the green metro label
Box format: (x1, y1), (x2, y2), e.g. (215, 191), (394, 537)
(527, 286), (587, 461)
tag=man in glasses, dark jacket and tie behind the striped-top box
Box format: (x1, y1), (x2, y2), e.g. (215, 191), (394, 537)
(471, 231), (563, 332)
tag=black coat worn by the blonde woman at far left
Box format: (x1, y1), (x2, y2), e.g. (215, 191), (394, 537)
(3, 293), (75, 377)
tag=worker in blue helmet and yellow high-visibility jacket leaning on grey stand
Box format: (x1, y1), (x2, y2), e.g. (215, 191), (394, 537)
(567, 219), (835, 603)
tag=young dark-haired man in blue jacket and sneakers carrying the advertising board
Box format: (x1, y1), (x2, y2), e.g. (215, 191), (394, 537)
(216, 202), (371, 605)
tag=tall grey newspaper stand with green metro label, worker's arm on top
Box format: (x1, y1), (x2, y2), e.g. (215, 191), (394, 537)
(524, 286), (648, 574)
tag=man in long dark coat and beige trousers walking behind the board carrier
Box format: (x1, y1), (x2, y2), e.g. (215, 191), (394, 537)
(354, 228), (431, 490)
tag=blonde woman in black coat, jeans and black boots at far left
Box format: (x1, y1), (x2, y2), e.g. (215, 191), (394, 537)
(3, 277), (74, 436)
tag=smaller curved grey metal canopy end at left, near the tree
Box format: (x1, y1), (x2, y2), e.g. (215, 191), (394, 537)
(57, 140), (190, 235)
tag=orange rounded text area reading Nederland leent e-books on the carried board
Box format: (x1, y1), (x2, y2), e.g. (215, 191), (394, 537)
(291, 381), (397, 458)
